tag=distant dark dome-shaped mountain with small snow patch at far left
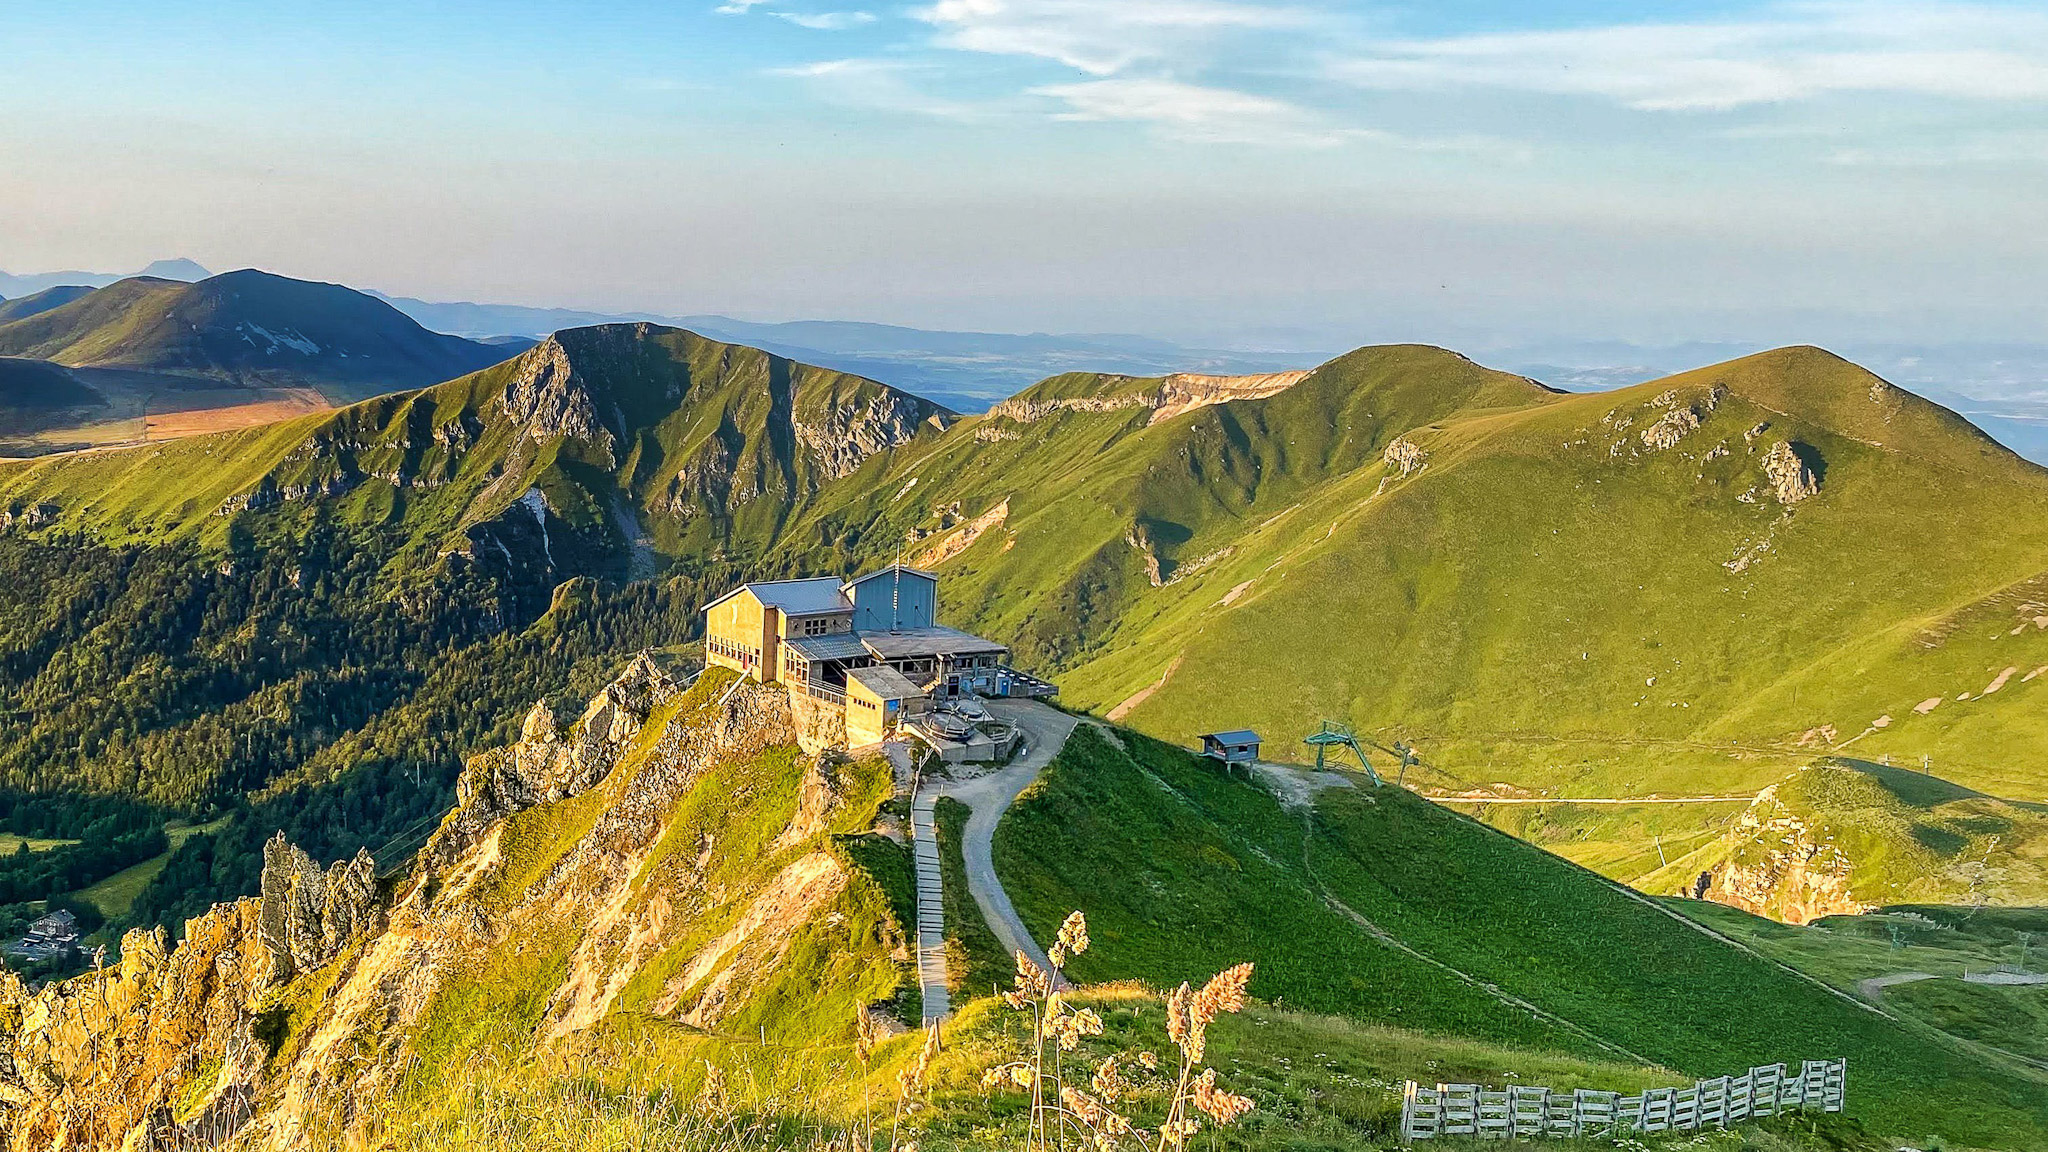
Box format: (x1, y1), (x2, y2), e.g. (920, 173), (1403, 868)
(0, 271), (502, 400)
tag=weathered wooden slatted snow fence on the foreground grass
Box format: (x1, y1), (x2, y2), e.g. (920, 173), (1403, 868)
(1401, 1060), (1849, 1144)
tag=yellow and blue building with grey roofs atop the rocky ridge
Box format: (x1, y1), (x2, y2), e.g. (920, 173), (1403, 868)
(705, 564), (1055, 746)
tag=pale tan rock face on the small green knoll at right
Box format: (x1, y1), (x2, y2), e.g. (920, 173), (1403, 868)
(1694, 785), (1868, 924)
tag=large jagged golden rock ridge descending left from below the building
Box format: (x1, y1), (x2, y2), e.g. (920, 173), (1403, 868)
(0, 656), (850, 1152)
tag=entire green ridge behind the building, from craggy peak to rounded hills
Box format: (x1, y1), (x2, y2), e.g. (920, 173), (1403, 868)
(0, 324), (2048, 922)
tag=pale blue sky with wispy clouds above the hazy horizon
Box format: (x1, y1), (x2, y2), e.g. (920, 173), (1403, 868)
(0, 0), (2048, 346)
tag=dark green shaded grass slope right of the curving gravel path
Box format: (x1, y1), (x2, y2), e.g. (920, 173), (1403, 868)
(997, 730), (2048, 1146)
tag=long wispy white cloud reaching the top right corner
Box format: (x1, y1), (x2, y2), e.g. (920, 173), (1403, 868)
(1329, 2), (2048, 111)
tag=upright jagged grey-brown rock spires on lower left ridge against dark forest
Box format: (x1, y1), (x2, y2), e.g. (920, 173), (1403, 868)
(258, 832), (383, 982)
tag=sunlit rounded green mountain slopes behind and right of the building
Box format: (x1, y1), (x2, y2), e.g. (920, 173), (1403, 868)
(765, 346), (2048, 811)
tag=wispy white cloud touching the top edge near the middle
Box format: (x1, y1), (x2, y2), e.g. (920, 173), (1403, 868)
(913, 0), (1309, 76)
